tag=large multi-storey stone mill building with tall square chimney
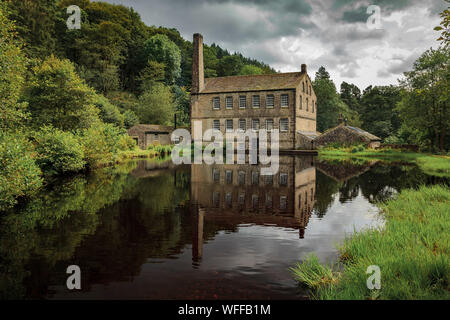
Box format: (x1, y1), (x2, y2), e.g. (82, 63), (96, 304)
(191, 34), (317, 150)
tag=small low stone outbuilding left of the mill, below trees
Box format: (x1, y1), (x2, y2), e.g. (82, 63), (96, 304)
(128, 124), (174, 150)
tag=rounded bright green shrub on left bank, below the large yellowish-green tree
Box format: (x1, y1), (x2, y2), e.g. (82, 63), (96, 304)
(34, 126), (86, 175)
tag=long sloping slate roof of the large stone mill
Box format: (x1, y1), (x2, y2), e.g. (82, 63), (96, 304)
(200, 72), (305, 93)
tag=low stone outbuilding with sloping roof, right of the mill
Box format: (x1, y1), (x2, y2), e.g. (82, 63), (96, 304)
(314, 124), (381, 149)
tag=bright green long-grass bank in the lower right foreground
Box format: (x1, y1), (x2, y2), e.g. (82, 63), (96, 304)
(292, 186), (450, 299)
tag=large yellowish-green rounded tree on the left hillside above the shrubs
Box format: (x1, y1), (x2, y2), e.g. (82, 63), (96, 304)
(25, 56), (99, 130)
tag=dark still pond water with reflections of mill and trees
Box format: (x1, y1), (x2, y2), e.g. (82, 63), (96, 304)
(0, 157), (448, 299)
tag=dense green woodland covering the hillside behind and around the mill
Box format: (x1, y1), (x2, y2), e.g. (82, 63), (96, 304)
(0, 0), (450, 211)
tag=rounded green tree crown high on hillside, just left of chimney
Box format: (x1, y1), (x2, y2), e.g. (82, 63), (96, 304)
(144, 34), (181, 84)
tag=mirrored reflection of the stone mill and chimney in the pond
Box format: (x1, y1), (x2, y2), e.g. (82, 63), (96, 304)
(191, 156), (316, 257)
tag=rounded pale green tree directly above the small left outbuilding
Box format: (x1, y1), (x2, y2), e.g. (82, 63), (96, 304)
(135, 83), (174, 125)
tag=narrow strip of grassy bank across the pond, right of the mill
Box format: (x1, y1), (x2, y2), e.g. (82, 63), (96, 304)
(319, 147), (450, 177)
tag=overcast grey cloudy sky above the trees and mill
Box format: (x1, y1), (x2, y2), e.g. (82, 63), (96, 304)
(96, 0), (445, 90)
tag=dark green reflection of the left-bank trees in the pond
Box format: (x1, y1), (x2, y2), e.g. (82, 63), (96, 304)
(0, 162), (139, 298)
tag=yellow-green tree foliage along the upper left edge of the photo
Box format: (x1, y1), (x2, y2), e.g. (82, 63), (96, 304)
(0, 3), (26, 131)
